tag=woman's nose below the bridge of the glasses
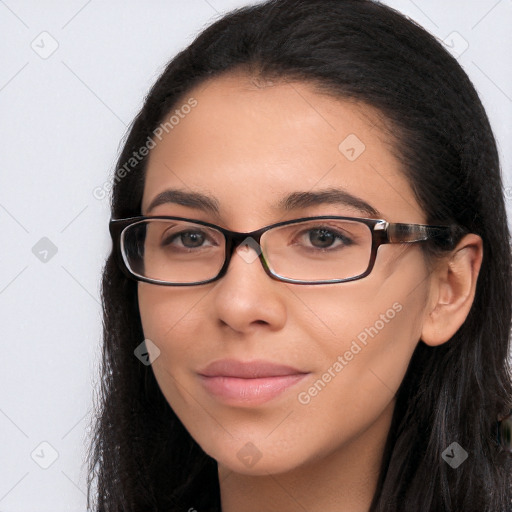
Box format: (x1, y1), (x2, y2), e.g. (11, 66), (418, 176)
(212, 237), (287, 332)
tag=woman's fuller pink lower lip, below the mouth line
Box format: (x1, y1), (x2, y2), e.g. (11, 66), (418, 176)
(199, 373), (308, 405)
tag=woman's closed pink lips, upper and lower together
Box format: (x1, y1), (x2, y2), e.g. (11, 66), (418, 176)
(198, 359), (308, 405)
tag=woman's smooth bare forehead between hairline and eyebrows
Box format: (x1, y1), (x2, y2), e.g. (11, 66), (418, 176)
(142, 74), (424, 229)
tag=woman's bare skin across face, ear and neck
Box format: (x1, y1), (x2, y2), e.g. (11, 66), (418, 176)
(138, 73), (482, 512)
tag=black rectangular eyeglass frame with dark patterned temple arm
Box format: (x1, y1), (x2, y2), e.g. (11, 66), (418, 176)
(109, 215), (464, 286)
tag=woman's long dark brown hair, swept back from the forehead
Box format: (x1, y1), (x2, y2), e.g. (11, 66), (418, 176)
(88, 0), (512, 512)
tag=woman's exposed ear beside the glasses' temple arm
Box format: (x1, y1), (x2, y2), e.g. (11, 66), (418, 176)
(421, 233), (483, 346)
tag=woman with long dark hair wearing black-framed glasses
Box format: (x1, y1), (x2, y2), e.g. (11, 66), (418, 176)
(90, 0), (512, 512)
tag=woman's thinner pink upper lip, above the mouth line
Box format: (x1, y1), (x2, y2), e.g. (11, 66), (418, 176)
(198, 359), (307, 379)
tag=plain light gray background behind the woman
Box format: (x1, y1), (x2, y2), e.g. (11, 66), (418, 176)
(0, 0), (512, 512)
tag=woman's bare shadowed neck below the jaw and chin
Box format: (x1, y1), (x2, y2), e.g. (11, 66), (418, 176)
(219, 401), (394, 512)
